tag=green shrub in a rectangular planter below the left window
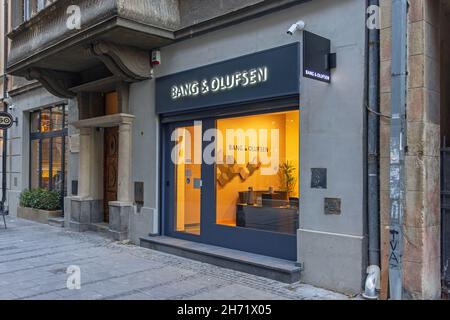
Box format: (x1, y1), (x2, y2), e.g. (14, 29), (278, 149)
(17, 189), (62, 224)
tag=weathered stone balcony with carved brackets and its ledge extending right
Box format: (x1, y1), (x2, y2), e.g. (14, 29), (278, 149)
(8, 0), (311, 98)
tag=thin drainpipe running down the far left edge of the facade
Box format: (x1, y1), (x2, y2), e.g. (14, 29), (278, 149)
(0, 0), (9, 215)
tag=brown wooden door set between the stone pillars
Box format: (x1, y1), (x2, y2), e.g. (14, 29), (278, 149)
(103, 127), (119, 222)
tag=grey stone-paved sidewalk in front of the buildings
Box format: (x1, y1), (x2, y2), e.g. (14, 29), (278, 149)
(0, 219), (347, 300)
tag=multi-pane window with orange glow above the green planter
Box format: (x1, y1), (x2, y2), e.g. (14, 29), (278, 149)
(30, 105), (68, 197)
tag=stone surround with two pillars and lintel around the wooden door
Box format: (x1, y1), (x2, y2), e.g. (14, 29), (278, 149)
(70, 113), (135, 240)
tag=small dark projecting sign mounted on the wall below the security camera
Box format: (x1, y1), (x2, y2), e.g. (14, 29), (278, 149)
(303, 31), (336, 83)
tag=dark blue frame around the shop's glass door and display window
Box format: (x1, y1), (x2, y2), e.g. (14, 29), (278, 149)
(159, 102), (301, 261)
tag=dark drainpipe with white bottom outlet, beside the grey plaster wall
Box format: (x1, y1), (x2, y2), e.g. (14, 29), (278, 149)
(363, 0), (380, 299)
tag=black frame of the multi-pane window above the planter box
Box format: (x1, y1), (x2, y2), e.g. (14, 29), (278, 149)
(29, 103), (69, 200)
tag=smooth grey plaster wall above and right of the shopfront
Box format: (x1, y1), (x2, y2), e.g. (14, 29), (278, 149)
(152, 0), (366, 293)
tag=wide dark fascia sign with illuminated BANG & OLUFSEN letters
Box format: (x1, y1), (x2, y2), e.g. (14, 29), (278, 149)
(156, 43), (300, 114)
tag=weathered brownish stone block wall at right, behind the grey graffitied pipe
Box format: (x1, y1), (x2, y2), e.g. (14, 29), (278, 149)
(380, 0), (440, 299)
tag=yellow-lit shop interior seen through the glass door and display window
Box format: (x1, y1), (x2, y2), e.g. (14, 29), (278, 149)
(172, 110), (300, 235)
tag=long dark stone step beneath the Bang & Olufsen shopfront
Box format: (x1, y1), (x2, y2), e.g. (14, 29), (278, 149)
(140, 236), (300, 283)
